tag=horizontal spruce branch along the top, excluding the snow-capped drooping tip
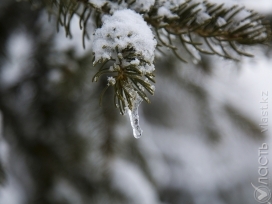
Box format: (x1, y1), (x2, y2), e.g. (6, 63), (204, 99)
(27, 0), (271, 61)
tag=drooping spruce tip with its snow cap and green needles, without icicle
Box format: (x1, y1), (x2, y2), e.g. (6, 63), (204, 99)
(93, 9), (156, 114)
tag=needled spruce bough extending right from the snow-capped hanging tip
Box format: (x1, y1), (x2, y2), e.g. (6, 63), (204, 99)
(149, 0), (271, 61)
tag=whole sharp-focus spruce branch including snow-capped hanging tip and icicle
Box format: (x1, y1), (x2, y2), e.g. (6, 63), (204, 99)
(23, 0), (271, 138)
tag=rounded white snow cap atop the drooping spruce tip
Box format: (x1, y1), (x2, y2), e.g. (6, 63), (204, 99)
(93, 9), (156, 72)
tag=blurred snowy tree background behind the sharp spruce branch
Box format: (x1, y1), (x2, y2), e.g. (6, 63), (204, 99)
(0, 0), (272, 204)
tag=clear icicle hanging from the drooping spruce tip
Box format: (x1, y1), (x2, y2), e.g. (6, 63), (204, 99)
(128, 94), (143, 139)
